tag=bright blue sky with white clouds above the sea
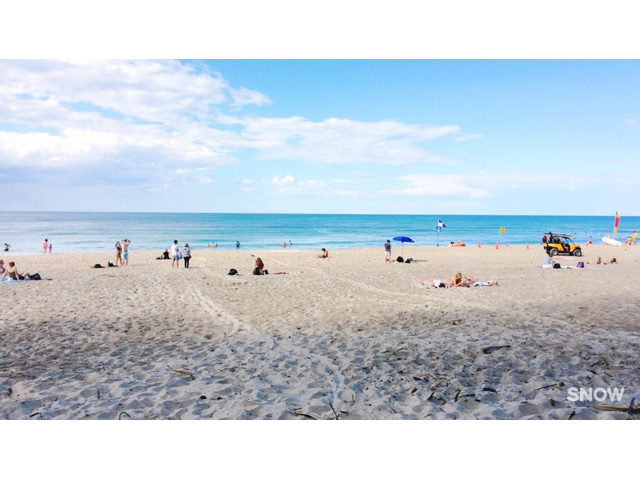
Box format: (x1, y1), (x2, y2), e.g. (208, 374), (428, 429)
(0, 60), (640, 215)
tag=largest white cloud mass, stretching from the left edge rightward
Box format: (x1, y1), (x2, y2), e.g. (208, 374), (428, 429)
(0, 60), (475, 189)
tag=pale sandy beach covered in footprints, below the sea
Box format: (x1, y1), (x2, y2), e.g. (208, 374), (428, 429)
(0, 245), (640, 419)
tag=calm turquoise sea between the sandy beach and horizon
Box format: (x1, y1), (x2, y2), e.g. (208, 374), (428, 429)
(0, 212), (640, 254)
